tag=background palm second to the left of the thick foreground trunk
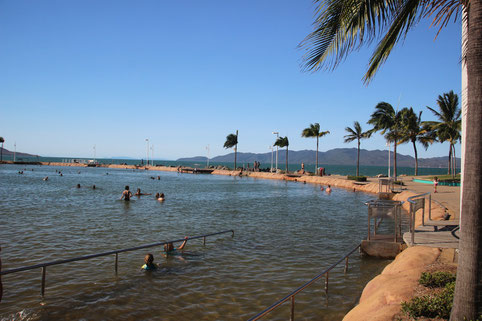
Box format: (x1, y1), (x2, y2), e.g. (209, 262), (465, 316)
(400, 107), (434, 176)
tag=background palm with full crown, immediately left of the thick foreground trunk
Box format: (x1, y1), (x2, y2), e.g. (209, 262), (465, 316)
(424, 90), (462, 176)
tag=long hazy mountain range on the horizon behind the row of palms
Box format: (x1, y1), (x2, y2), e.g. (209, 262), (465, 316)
(177, 148), (460, 168)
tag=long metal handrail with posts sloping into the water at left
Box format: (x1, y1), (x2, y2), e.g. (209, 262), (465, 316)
(0, 230), (234, 296)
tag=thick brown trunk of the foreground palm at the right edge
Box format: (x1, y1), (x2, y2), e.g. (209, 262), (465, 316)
(450, 0), (482, 321)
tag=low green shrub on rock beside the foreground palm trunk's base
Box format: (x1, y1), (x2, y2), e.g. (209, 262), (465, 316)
(402, 282), (455, 319)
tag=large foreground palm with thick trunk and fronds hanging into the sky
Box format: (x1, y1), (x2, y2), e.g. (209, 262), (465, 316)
(300, 0), (482, 321)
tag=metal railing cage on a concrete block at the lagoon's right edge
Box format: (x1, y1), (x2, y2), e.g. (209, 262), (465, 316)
(361, 199), (403, 258)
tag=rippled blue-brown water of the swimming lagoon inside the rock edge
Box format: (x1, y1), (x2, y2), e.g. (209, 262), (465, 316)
(0, 165), (387, 320)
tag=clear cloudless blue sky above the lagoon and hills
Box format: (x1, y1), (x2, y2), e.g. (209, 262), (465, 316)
(0, 0), (461, 160)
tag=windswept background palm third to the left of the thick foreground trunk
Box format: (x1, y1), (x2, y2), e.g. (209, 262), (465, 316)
(368, 102), (402, 180)
